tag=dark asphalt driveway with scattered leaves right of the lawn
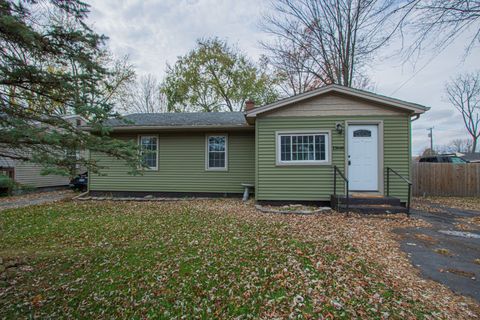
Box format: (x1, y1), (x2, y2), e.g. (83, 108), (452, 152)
(396, 203), (480, 302)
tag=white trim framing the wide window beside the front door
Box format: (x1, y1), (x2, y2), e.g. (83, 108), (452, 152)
(275, 130), (332, 166)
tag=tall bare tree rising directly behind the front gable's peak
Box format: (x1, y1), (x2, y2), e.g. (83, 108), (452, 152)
(262, 0), (398, 91)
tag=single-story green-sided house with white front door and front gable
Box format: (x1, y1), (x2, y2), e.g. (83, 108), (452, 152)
(87, 85), (428, 208)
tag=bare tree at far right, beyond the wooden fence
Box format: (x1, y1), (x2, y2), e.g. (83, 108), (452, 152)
(445, 71), (480, 152)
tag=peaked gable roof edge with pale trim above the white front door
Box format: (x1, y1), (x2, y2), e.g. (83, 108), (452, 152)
(246, 85), (430, 118)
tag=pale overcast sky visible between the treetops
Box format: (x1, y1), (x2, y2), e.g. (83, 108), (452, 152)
(88, 0), (480, 154)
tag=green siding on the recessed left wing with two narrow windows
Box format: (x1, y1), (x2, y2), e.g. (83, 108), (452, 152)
(90, 132), (255, 193)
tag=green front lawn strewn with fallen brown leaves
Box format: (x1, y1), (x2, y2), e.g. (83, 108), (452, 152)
(0, 200), (478, 319)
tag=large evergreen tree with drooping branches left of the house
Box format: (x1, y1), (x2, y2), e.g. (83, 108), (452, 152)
(0, 0), (139, 173)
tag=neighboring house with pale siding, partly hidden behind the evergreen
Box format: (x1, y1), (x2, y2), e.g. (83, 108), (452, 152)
(0, 115), (86, 188)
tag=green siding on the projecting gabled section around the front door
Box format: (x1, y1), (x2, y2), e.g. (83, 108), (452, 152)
(256, 115), (410, 201)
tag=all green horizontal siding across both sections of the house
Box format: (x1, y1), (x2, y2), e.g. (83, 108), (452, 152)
(89, 115), (411, 201)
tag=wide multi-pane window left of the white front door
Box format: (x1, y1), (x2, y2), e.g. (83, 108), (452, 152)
(277, 133), (329, 164)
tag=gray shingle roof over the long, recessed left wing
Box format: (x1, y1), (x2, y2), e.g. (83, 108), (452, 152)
(105, 112), (247, 128)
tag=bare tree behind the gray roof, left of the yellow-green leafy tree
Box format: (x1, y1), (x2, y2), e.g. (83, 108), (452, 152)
(117, 74), (167, 113)
